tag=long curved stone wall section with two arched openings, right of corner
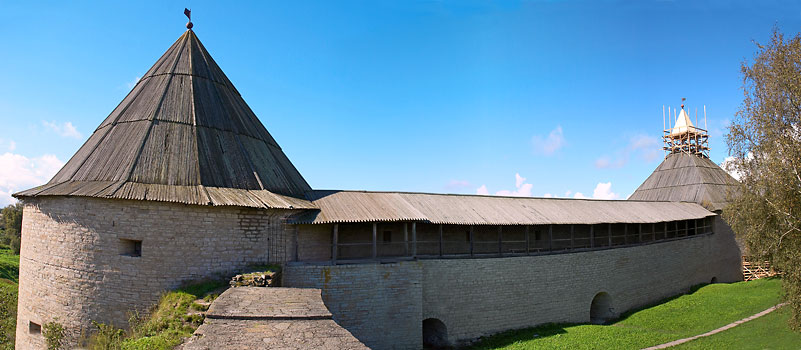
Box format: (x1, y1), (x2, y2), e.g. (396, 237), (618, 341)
(422, 224), (742, 341)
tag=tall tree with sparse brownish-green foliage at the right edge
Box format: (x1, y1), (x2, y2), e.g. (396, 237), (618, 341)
(724, 28), (801, 330)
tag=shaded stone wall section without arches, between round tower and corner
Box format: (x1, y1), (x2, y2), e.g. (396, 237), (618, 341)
(283, 261), (423, 350)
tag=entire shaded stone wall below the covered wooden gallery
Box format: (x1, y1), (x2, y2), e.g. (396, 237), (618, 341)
(284, 226), (742, 349)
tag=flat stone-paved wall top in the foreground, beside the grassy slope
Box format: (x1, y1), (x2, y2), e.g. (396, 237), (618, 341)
(178, 287), (367, 350)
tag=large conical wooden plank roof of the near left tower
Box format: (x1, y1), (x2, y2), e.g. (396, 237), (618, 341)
(16, 30), (313, 208)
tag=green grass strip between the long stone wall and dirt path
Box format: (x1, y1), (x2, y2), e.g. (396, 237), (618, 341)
(472, 279), (786, 349)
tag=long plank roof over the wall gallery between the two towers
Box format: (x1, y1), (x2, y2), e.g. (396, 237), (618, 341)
(293, 190), (715, 225)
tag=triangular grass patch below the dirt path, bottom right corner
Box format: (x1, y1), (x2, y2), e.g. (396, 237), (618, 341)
(671, 307), (801, 350)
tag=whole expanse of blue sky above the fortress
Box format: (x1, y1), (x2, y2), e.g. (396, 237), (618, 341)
(0, 0), (801, 204)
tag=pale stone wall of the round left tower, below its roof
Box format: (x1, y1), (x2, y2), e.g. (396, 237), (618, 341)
(17, 197), (291, 349)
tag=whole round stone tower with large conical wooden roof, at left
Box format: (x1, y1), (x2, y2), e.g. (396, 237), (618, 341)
(15, 29), (314, 349)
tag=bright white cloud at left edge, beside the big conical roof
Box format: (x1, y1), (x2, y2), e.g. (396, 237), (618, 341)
(0, 152), (64, 206)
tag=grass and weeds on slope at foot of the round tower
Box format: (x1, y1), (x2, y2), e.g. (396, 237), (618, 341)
(89, 281), (226, 350)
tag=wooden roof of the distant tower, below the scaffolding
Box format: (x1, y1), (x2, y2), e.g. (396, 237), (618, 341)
(629, 153), (737, 211)
